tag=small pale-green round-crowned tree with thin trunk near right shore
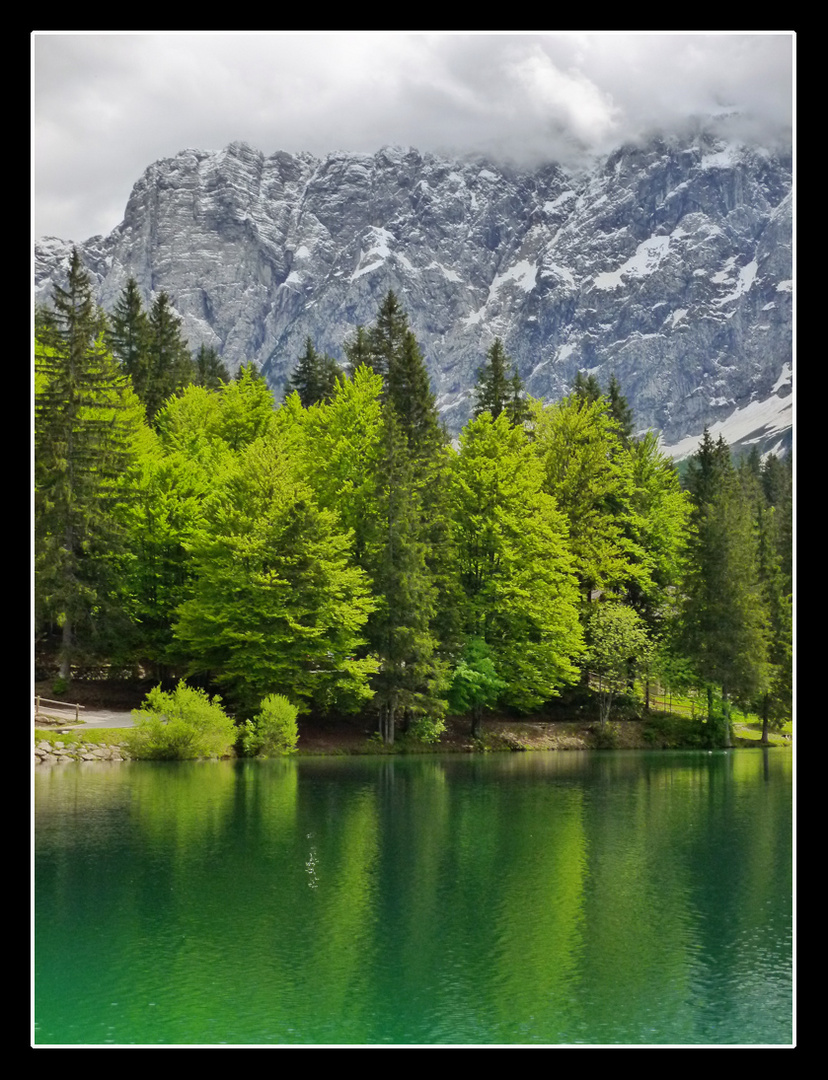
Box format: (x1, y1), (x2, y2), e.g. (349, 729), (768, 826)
(586, 600), (653, 726)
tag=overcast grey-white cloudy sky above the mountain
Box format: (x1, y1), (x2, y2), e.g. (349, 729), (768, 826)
(32, 31), (795, 241)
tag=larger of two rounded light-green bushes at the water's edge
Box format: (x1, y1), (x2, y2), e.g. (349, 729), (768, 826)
(124, 680), (236, 760)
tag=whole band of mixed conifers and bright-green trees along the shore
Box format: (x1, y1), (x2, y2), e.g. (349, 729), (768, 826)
(33, 252), (793, 745)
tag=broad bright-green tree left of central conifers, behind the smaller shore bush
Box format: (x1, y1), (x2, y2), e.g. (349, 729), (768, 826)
(175, 429), (377, 710)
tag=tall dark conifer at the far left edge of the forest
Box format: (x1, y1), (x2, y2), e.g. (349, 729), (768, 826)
(35, 249), (139, 678)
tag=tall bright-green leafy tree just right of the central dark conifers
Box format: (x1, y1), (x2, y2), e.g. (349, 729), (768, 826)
(452, 413), (582, 711)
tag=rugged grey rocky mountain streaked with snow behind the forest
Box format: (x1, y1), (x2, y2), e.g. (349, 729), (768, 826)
(36, 135), (792, 457)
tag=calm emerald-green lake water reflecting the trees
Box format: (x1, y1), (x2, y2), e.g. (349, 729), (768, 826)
(33, 750), (792, 1045)
